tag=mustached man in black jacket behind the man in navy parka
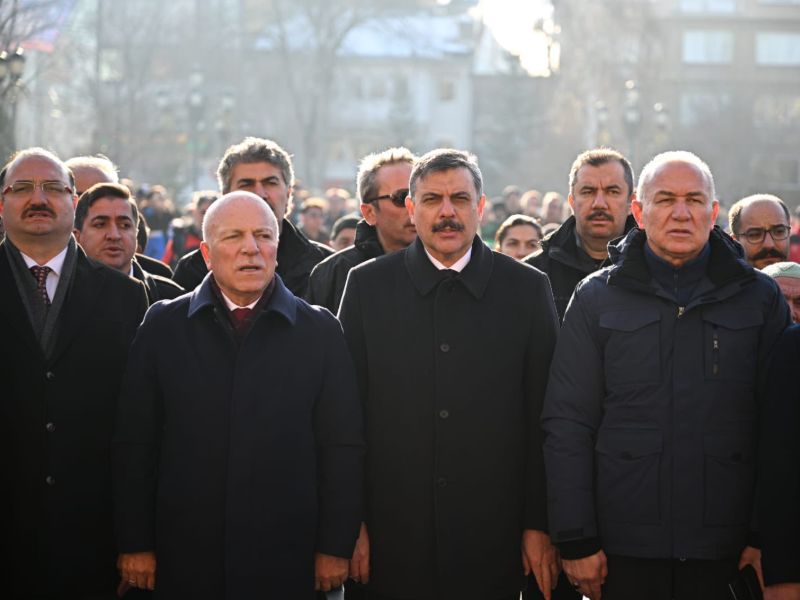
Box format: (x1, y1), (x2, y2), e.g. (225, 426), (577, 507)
(525, 148), (636, 320)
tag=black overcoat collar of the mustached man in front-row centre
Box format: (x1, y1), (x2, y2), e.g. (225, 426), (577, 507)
(402, 235), (494, 299)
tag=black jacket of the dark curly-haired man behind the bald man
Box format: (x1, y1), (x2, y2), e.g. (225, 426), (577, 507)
(172, 219), (333, 298)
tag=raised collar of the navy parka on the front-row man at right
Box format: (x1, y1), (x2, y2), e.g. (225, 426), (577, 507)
(608, 226), (755, 288)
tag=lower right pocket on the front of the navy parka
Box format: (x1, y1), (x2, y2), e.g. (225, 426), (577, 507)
(703, 433), (755, 525)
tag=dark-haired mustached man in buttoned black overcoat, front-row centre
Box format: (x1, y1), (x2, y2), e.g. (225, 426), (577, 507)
(339, 150), (572, 600)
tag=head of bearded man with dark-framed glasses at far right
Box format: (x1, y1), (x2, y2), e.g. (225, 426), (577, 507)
(728, 194), (791, 269)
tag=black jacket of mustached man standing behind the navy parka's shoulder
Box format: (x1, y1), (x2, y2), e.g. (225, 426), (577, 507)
(525, 215), (636, 321)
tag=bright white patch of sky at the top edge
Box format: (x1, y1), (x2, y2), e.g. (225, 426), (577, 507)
(476, 0), (553, 76)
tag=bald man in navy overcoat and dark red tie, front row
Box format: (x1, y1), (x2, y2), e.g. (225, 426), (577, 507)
(114, 192), (364, 600)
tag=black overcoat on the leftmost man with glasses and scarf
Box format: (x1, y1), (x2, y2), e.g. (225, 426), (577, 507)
(0, 244), (147, 598)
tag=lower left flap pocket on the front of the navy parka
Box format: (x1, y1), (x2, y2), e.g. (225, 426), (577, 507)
(595, 429), (663, 523)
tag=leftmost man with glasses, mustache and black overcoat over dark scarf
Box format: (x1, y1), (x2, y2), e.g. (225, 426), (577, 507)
(0, 148), (146, 599)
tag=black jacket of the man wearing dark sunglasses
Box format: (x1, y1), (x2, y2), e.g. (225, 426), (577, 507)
(306, 220), (384, 314)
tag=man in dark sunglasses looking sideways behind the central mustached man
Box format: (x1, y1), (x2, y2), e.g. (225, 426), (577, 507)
(306, 148), (417, 313)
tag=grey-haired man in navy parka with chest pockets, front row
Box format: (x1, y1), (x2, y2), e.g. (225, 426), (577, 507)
(542, 152), (790, 600)
